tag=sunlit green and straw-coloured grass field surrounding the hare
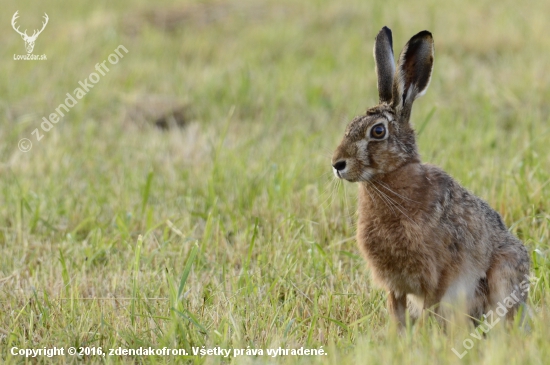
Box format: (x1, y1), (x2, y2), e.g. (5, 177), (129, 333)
(0, 0), (550, 364)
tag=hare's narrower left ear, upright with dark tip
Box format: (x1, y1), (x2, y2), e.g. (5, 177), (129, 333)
(374, 27), (395, 103)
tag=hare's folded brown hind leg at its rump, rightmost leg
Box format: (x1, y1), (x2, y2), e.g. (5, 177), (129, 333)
(485, 240), (529, 321)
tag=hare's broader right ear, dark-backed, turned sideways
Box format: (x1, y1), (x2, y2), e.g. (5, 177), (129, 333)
(392, 30), (434, 121)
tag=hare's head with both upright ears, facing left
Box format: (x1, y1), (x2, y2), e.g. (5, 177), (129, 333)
(332, 27), (434, 181)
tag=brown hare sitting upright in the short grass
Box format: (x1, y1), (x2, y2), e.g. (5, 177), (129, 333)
(332, 27), (529, 327)
